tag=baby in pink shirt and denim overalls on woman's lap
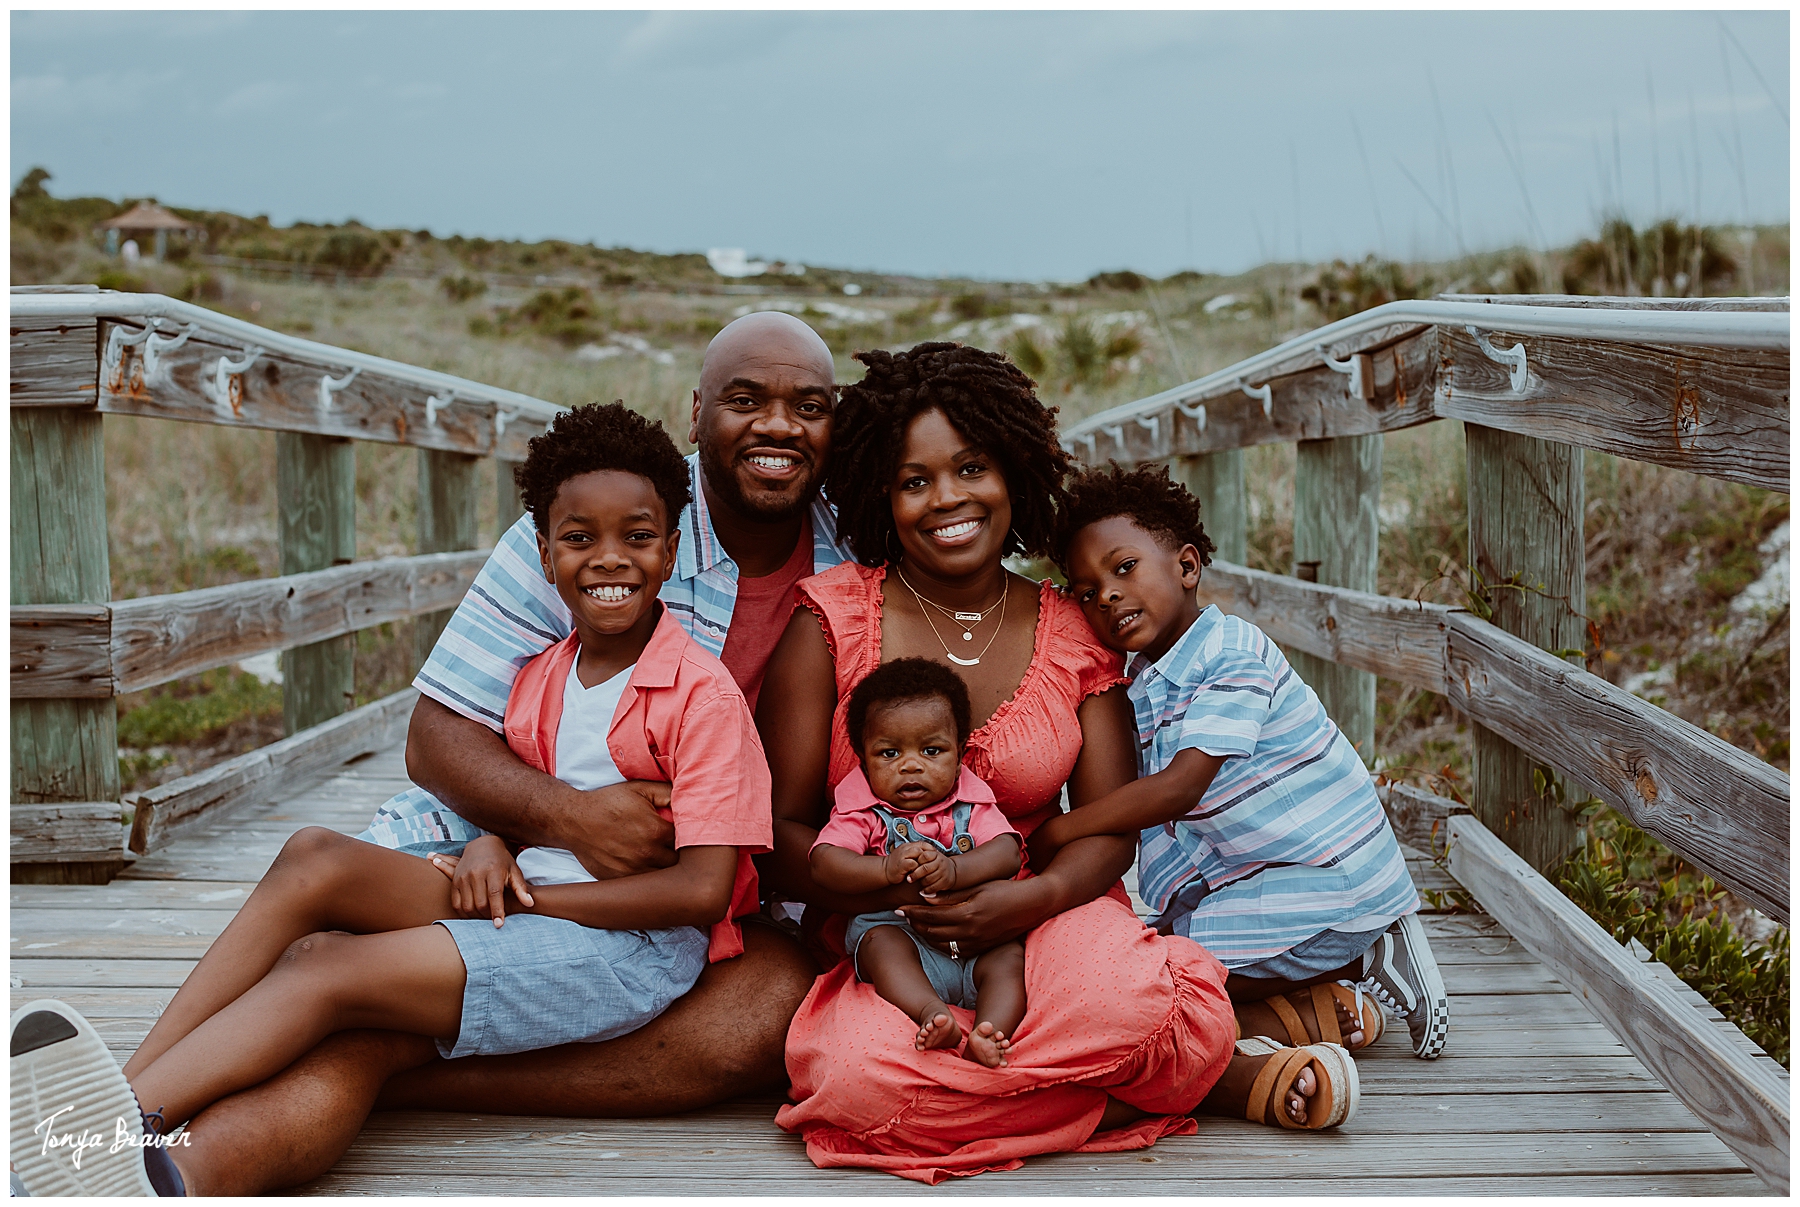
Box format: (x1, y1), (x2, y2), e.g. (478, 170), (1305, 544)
(812, 658), (1024, 1068)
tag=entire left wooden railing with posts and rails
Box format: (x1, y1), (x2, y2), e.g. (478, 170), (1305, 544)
(11, 286), (556, 881)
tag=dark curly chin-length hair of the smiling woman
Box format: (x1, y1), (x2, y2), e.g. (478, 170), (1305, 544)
(824, 344), (1071, 567)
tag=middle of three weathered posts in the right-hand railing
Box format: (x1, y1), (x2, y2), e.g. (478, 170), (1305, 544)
(1289, 435), (1382, 763)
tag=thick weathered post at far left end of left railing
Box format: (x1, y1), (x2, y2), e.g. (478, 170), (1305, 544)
(11, 402), (124, 885)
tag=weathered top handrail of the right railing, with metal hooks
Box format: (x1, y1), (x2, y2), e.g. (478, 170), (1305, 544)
(1062, 299), (1789, 491)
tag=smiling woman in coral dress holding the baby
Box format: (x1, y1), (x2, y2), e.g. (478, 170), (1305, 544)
(758, 344), (1233, 1182)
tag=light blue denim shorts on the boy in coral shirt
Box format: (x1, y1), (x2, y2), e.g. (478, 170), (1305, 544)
(437, 914), (709, 1059)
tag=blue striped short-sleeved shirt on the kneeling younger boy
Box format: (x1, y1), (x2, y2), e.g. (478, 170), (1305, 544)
(1127, 606), (1418, 968)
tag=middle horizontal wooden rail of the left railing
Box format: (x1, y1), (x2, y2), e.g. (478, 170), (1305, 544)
(13, 549), (488, 700)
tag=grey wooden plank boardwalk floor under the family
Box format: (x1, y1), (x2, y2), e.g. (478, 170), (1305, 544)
(11, 747), (1769, 1194)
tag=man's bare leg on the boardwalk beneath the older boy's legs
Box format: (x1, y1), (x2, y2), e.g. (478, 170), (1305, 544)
(156, 920), (819, 1194)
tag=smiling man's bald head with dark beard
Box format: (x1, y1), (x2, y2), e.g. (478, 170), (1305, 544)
(688, 311), (837, 525)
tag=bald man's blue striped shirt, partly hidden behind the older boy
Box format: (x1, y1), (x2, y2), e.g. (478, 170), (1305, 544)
(360, 453), (848, 847)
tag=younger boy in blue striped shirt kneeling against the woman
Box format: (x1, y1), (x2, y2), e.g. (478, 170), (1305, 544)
(1031, 466), (1449, 1059)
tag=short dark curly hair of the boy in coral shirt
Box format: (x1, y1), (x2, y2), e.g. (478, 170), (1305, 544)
(513, 403), (691, 532)
